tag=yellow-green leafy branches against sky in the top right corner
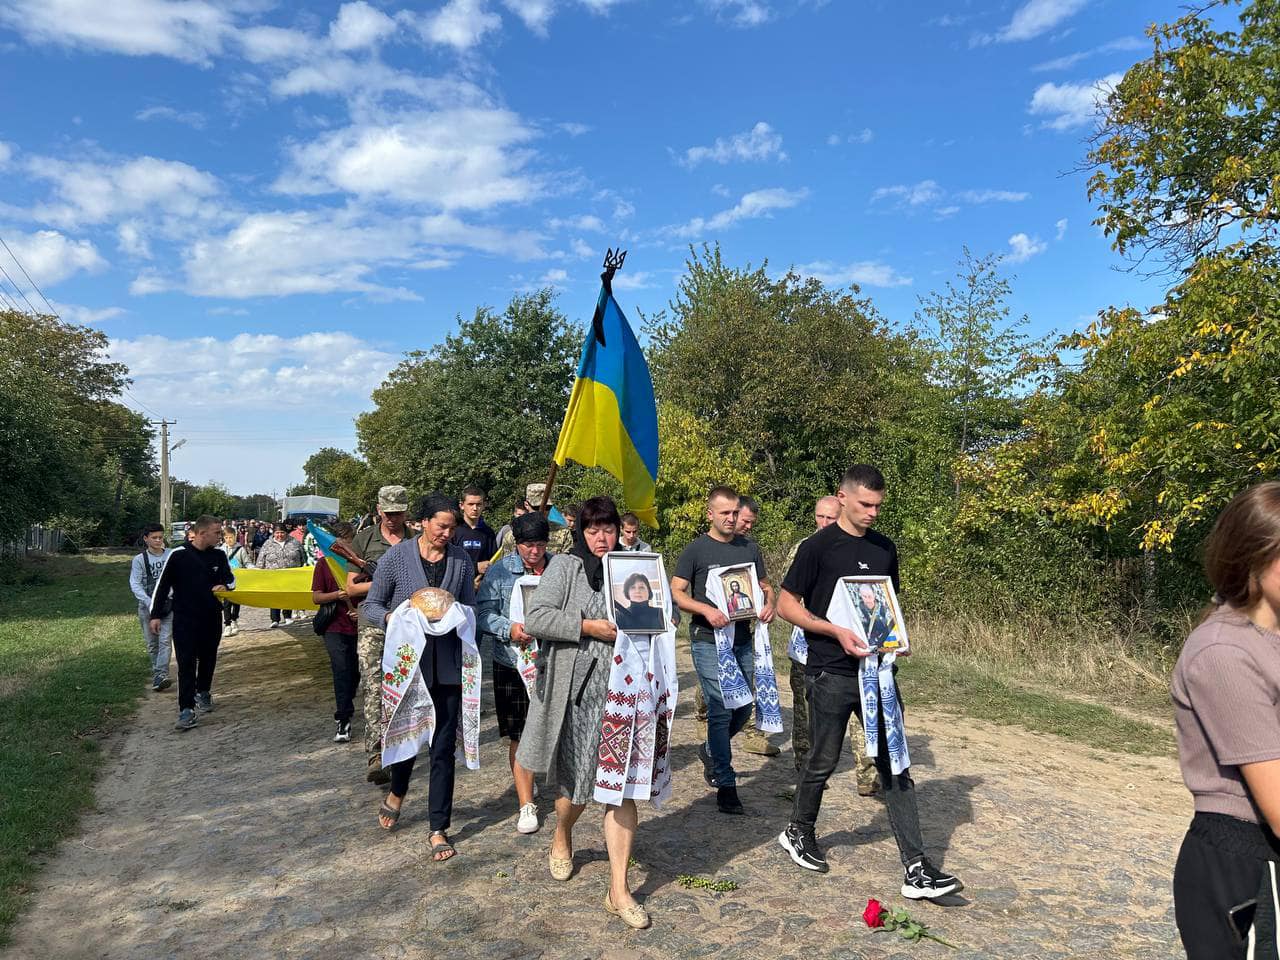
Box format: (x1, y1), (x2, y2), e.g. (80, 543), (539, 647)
(1089, 0), (1280, 269)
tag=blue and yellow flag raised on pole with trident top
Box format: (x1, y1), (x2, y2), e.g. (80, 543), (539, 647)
(554, 251), (658, 527)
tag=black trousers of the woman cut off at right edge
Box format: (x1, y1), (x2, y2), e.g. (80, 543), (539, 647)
(1174, 813), (1280, 960)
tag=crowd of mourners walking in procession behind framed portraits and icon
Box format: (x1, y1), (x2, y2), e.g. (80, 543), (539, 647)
(131, 466), (963, 928)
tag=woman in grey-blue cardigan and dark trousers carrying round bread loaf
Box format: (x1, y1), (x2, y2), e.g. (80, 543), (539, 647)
(360, 493), (476, 861)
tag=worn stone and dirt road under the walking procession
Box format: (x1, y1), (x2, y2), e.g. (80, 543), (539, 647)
(5, 608), (1190, 960)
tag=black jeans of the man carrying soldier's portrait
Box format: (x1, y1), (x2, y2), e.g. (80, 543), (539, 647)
(791, 672), (924, 867)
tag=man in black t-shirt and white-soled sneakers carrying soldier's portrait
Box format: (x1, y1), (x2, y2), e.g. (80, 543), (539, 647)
(778, 465), (964, 900)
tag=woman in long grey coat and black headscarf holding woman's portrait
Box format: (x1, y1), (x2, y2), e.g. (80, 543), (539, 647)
(516, 497), (650, 929)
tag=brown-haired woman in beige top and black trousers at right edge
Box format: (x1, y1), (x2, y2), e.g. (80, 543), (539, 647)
(1171, 483), (1280, 960)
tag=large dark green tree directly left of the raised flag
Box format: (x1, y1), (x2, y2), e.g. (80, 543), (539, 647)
(356, 289), (581, 504)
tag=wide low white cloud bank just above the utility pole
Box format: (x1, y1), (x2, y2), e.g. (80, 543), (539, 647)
(108, 332), (397, 409)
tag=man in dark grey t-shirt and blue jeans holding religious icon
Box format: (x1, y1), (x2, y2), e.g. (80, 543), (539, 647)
(671, 486), (773, 814)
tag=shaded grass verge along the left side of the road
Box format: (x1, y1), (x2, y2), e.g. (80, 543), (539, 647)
(0, 557), (148, 945)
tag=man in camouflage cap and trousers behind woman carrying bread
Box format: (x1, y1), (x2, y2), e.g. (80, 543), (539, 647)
(347, 485), (412, 783)
